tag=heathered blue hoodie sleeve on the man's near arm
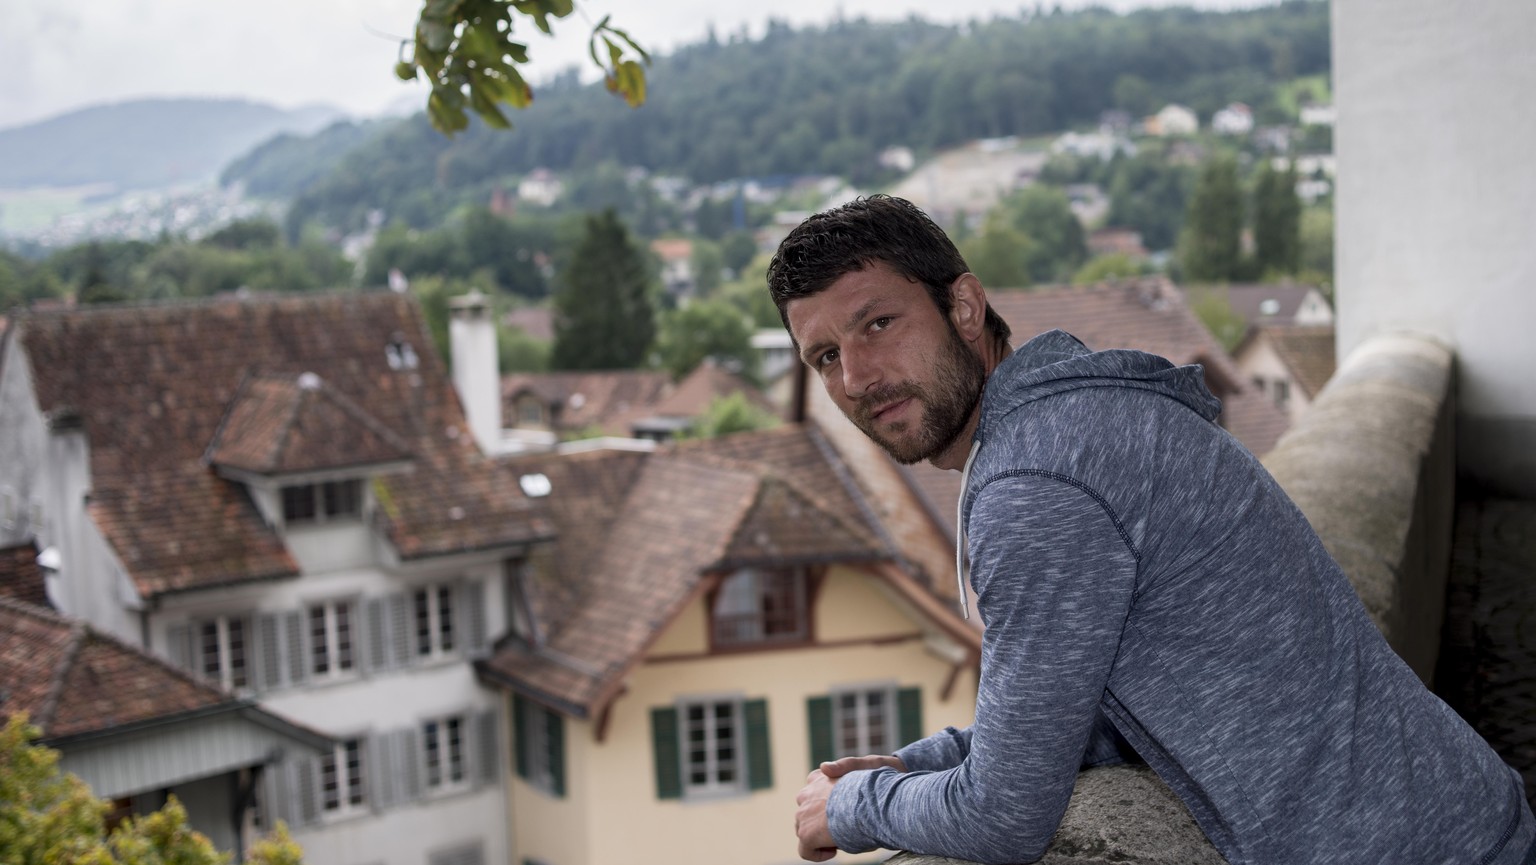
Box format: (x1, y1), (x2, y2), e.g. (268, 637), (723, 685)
(826, 473), (1137, 863)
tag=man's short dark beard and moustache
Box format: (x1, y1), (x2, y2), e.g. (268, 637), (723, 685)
(848, 321), (986, 466)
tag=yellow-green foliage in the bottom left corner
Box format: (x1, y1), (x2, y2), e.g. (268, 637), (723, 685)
(0, 713), (303, 865)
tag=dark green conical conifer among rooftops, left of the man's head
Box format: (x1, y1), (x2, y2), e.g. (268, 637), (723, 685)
(550, 209), (656, 369)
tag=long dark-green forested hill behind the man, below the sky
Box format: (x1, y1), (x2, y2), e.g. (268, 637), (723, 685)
(245, 0), (1329, 233)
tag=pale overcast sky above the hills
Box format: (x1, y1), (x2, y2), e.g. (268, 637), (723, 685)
(0, 0), (1269, 129)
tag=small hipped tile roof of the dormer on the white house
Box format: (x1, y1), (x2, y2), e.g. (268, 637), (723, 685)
(207, 372), (412, 475)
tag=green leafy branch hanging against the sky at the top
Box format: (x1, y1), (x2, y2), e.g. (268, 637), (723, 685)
(395, 0), (651, 135)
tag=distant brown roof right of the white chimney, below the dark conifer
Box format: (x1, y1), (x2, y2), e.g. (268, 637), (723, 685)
(501, 369), (671, 436)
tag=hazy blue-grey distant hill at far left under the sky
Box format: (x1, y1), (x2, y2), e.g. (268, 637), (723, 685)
(0, 100), (339, 189)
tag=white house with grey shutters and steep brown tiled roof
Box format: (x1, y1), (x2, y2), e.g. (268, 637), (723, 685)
(0, 293), (551, 865)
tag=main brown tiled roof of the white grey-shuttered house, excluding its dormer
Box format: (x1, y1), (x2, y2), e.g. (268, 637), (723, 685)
(18, 292), (551, 596)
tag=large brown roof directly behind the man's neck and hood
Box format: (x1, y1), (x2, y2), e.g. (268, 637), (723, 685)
(849, 277), (1289, 540)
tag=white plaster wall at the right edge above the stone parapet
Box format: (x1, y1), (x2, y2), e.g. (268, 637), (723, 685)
(1332, 0), (1536, 493)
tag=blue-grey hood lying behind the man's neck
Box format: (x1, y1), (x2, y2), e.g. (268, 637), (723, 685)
(975, 330), (1221, 444)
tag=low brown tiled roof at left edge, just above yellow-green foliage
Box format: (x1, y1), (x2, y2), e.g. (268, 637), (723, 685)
(0, 598), (237, 739)
